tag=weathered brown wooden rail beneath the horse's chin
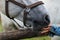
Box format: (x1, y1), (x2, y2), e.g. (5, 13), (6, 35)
(0, 30), (48, 40)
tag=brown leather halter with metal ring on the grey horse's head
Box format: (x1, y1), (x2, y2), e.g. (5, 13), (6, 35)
(5, 0), (44, 26)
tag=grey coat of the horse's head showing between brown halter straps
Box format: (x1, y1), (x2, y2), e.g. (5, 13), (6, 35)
(6, 0), (50, 30)
